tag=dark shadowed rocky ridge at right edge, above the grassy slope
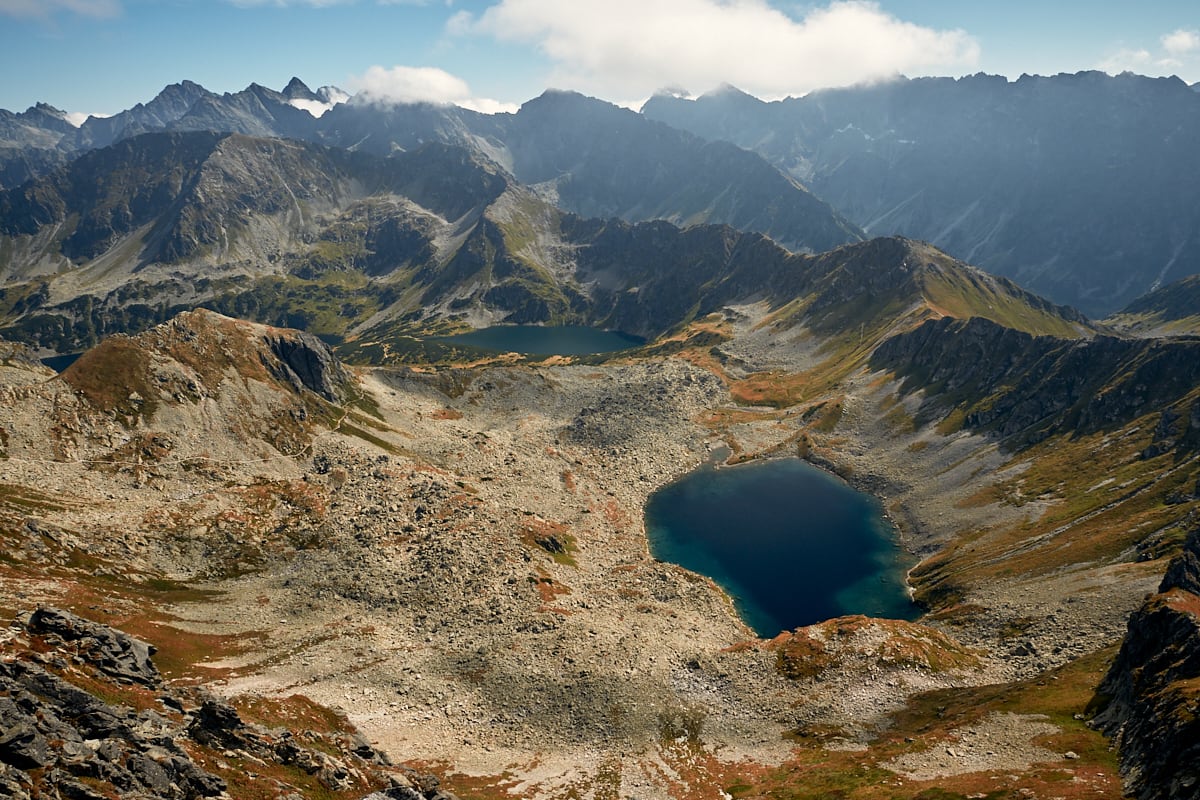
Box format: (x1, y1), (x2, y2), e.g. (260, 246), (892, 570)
(871, 317), (1200, 457)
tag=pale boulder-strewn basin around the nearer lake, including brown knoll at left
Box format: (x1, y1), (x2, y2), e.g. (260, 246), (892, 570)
(0, 307), (1180, 798)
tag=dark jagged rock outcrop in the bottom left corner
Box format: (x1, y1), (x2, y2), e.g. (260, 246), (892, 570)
(0, 608), (455, 800)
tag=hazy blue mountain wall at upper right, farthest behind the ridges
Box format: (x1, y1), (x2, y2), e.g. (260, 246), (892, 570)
(642, 72), (1200, 317)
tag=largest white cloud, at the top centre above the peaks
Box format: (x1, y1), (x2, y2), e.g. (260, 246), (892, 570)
(446, 0), (979, 97)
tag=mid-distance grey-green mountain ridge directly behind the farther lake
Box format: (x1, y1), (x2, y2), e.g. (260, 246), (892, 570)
(0, 126), (1085, 351)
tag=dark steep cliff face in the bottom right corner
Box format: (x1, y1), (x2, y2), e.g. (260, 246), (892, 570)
(1093, 529), (1200, 800)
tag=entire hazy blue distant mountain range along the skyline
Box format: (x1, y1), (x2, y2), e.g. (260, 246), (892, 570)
(9, 73), (1200, 317)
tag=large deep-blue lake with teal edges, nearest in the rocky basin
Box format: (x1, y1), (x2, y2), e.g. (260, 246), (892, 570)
(646, 458), (920, 637)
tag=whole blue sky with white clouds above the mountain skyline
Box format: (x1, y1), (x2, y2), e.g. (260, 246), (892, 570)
(0, 0), (1200, 120)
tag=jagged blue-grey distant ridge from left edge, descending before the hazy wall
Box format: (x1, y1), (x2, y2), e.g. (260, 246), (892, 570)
(0, 79), (862, 262)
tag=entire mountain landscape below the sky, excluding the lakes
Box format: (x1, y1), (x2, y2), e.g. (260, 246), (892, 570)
(0, 73), (1200, 800)
